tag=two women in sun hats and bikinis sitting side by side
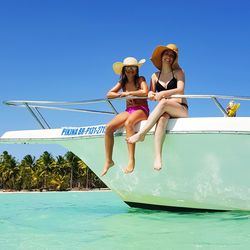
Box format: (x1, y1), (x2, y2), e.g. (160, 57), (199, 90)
(101, 44), (188, 176)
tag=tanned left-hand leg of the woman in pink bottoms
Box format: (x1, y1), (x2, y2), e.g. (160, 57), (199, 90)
(101, 112), (129, 176)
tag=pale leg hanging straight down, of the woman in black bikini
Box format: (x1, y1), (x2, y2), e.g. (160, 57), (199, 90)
(154, 113), (170, 170)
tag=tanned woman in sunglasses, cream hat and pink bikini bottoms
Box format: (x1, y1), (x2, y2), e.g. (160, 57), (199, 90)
(101, 57), (149, 176)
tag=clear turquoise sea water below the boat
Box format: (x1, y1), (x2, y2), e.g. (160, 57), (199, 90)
(0, 192), (250, 250)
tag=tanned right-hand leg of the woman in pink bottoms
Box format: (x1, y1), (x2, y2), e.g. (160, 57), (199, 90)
(124, 110), (147, 174)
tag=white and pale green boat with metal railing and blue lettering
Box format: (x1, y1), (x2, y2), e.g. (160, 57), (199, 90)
(0, 95), (250, 211)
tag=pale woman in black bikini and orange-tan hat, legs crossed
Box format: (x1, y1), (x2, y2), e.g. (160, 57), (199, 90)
(127, 44), (188, 170)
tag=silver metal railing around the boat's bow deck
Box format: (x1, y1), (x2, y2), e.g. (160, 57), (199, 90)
(3, 95), (250, 129)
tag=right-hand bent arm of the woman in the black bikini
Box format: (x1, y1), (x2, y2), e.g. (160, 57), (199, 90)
(156, 70), (185, 100)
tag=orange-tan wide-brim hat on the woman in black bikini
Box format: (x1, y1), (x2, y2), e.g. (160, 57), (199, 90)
(150, 44), (180, 70)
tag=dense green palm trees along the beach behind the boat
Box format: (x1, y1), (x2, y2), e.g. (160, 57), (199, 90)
(0, 151), (106, 191)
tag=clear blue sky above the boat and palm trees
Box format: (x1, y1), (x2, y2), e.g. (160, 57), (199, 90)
(0, 0), (250, 158)
